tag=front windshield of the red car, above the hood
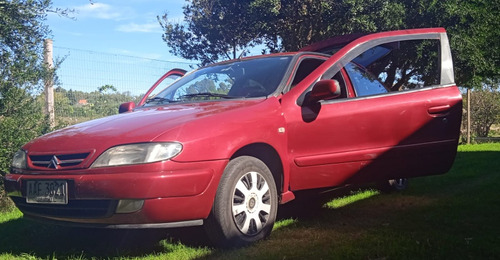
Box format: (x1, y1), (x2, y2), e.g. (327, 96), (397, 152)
(145, 56), (292, 106)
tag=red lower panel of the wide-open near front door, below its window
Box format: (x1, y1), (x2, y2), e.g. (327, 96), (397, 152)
(288, 86), (461, 190)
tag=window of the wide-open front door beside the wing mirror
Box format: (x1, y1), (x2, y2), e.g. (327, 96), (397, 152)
(322, 37), (442, 99)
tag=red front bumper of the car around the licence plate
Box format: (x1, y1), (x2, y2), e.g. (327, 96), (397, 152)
(6, 160), (227, 225)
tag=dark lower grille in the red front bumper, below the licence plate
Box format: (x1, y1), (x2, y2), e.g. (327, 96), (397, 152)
(11, 197), (118, 219)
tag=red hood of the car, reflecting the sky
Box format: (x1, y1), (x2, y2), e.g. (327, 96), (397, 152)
(23, 99), (264, 154)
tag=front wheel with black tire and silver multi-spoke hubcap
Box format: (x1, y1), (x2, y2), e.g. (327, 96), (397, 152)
(205, 156), (278, 248)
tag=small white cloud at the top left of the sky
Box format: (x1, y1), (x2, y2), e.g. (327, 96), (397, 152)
(75, 3), (134, 20)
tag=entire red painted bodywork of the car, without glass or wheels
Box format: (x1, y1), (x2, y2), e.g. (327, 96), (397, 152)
(5, 28), (462, 227)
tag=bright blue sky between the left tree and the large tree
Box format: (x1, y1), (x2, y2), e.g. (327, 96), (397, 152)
(46, 0), (196, 95)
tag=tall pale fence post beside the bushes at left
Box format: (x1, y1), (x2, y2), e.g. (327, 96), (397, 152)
(43, 39), (56, 128)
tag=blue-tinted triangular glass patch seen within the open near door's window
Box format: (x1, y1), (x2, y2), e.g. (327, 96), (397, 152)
(345, 62), (388, 97)
